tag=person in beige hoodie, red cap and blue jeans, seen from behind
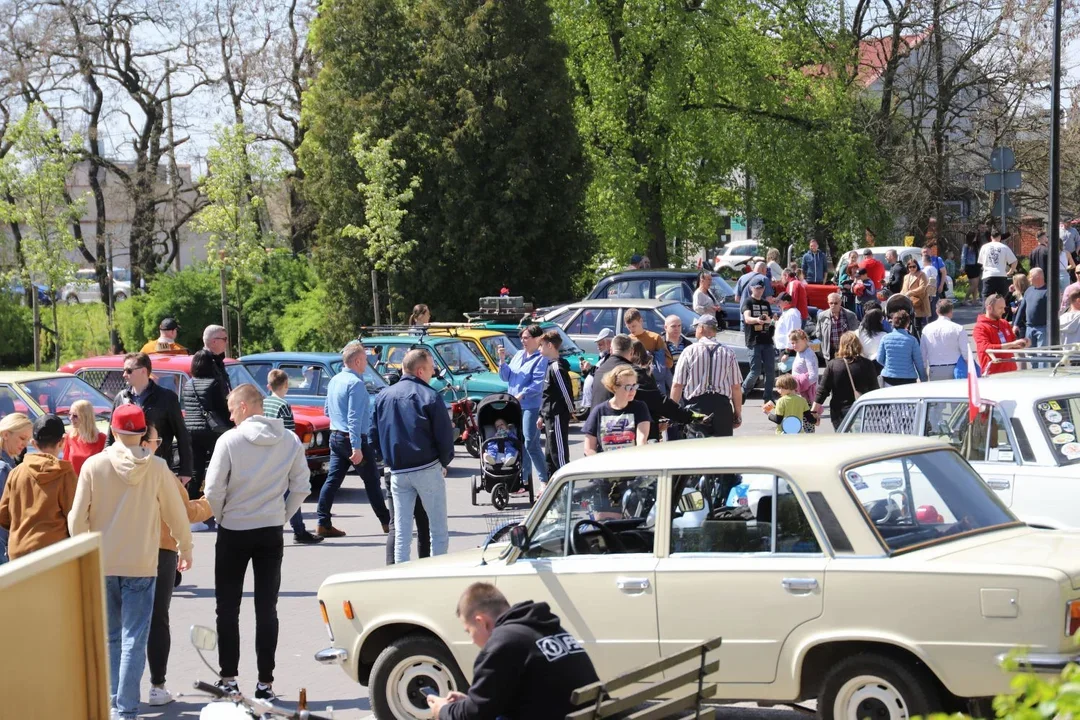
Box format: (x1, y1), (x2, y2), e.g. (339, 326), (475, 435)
(68, 405), (192, 720)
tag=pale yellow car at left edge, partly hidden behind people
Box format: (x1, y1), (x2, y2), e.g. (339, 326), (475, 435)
(0, 371), (112, 431)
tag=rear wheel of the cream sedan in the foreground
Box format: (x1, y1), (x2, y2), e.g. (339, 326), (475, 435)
(818, 653), (941, 720)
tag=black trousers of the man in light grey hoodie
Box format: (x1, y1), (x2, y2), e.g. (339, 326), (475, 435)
(214, 527), (285, 684)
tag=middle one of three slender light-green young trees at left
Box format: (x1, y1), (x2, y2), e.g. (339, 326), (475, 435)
(193, 124), (280, 354)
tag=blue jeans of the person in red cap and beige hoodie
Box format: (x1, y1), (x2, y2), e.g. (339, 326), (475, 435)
(105, 575), (158, 718)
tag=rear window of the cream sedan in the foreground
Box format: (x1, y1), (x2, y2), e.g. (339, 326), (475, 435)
(843, 450), (1020, 554)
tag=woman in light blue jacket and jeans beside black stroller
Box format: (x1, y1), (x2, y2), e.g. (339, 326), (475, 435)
(499, 325), (549, 488)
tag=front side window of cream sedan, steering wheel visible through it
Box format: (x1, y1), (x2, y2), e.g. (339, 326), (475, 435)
(523, 475), (659, 558)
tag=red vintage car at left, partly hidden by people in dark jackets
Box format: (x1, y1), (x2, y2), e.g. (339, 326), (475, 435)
(60, 355), (330, 487)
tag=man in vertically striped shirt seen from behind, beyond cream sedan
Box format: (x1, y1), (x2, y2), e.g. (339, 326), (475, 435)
(672, 315), (743, 437)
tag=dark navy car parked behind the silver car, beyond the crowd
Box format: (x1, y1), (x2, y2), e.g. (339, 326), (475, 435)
(585, 269), (739, 327)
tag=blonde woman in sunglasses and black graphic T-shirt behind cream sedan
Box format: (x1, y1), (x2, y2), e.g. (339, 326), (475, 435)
(582, 365), (652, 456)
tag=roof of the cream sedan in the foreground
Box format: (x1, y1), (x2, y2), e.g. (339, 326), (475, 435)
(567, 433), (948, 483)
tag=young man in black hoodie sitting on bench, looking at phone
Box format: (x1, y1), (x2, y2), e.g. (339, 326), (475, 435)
(428, 583), (599, 720)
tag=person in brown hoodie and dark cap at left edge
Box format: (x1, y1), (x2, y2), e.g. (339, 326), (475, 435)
(0, 415), (76, 560)
